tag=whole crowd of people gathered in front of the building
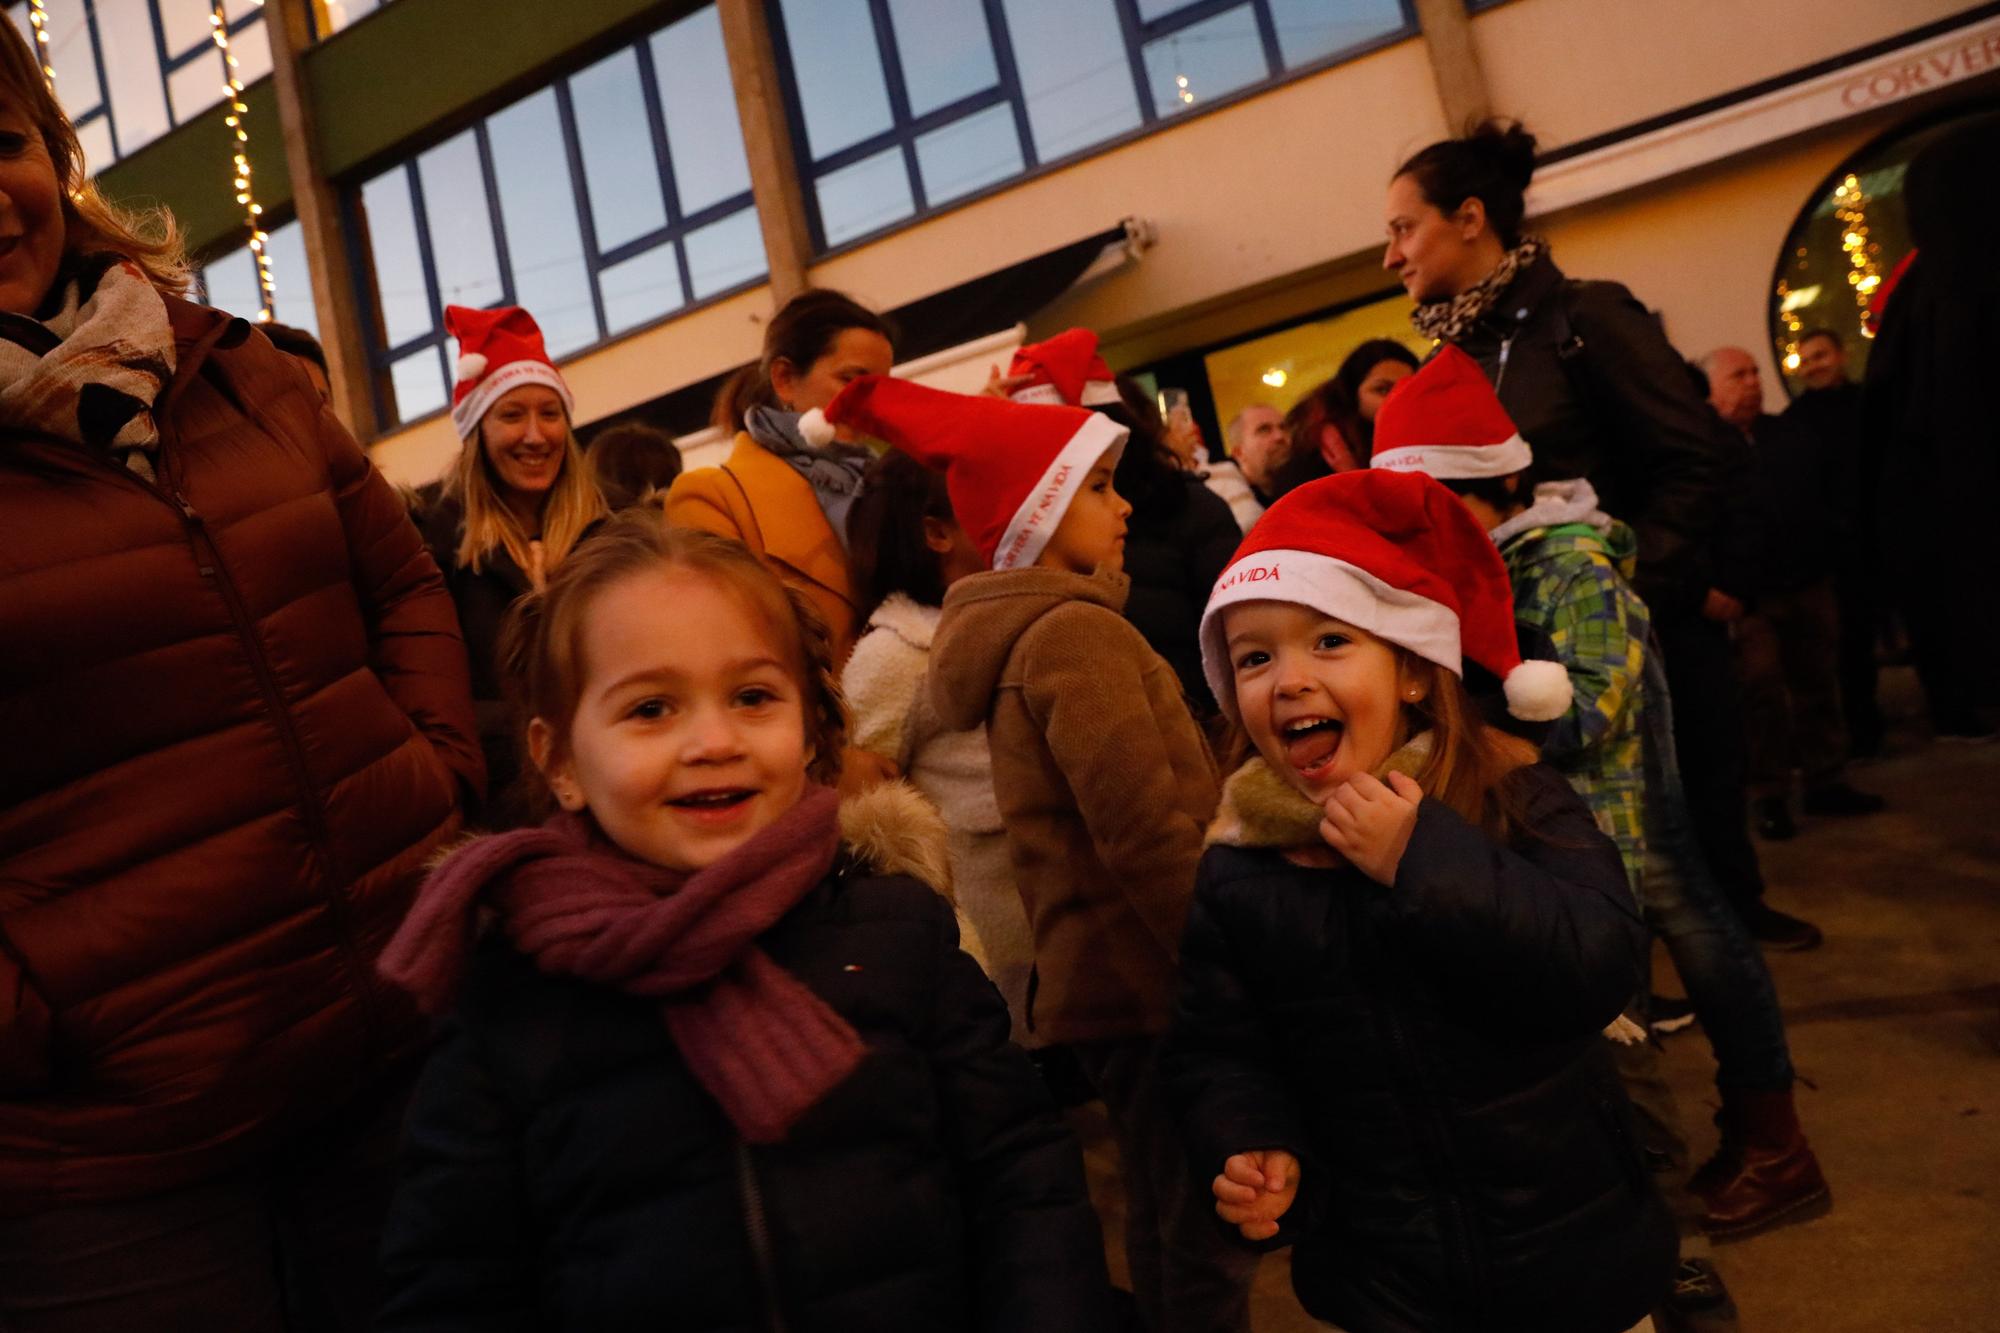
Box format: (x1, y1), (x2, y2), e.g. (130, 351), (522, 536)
(0, 10), (1996, 1333)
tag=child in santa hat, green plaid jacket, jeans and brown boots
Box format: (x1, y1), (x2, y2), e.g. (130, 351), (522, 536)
(1372, 346), (1828, 1256)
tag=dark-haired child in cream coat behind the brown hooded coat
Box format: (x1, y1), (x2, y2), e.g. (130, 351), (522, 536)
(840, 452), (1034, 1045)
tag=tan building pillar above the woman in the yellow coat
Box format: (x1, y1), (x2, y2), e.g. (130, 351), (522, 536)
(716, 0), (812, 306)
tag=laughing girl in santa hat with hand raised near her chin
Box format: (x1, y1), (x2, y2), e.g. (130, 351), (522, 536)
(1166, 472), (1674, 1333)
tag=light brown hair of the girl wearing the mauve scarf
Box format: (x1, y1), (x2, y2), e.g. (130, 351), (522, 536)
(500, 504), (848, 813)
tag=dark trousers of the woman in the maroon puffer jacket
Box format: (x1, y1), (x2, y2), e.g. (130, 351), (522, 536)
(0, 1069), (414, 1333)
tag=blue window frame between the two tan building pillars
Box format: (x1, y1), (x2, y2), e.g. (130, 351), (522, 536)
(340, 10), (770, 432)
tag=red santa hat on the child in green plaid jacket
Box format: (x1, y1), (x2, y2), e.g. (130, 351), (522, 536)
(1368, 342), (1534, 480)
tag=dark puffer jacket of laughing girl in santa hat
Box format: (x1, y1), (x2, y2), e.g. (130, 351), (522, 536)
(1166, 765), (1676, 1333)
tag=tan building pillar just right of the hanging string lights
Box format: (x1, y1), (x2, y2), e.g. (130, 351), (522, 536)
(264, 0), (378, 442)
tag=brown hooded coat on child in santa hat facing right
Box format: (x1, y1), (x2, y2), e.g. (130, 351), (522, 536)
(930, 568), (1218, 1041)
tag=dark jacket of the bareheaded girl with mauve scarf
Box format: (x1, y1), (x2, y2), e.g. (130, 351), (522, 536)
(378, 784), (1110, 1333)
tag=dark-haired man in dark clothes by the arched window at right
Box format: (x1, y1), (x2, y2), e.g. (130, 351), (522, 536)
(1784, 328), (1882, 759)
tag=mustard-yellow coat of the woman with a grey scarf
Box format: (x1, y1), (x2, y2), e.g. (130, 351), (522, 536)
(666, 432), (856, 669)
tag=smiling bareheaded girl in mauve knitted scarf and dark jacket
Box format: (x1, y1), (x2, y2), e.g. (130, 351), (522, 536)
(380, 512), (1106, 1333)
